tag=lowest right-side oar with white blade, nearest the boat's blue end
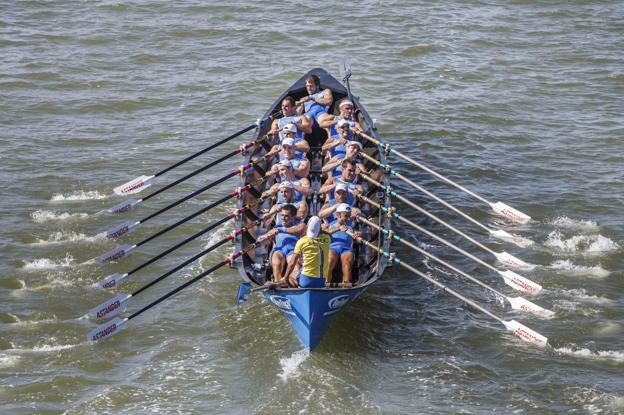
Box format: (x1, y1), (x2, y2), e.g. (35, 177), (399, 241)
(347, 231), (548, 346)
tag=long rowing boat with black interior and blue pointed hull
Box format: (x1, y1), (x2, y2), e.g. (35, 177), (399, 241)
(236, 68), (390, 350)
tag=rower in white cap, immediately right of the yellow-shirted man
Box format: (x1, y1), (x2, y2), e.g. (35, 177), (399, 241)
(325, 203), (359, 285)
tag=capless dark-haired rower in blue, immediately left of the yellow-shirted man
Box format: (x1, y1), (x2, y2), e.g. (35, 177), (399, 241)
(258, 204), (306, 282)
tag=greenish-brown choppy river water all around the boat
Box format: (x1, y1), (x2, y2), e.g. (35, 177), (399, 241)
(0, 0), (624, 414)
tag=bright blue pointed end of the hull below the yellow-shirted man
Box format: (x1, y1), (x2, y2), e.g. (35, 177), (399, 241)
(263, 285), (368, 350)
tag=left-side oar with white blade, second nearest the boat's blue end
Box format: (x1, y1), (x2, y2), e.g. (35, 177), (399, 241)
(87, 220), (261, 320)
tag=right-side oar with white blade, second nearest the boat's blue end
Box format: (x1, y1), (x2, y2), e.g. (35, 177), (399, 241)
(357, 217), (555, 317)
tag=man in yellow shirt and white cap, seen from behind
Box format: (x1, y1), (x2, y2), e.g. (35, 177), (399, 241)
(286, 216), (331, 288)
